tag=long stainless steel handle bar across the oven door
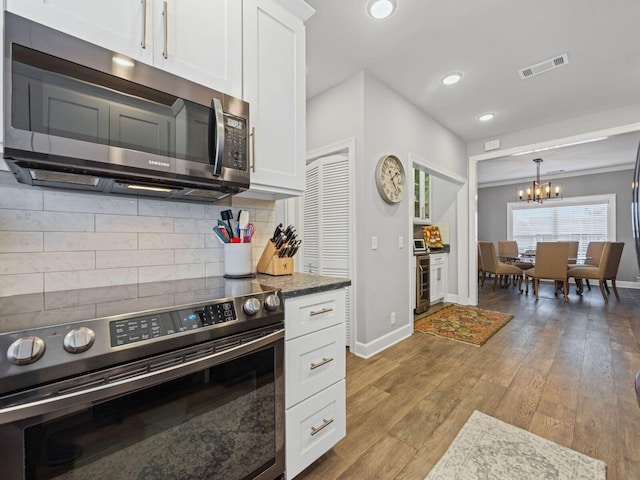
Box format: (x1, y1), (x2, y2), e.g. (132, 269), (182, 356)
(0, 329), (284, 425)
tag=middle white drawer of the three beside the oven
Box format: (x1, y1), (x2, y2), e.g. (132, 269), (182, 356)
(284, 324), (346, 408)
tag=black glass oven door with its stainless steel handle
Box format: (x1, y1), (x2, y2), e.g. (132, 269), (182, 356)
(0, 329), (284, 480)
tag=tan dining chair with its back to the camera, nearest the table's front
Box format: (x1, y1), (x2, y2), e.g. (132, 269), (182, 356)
(524, 242), (569, 302)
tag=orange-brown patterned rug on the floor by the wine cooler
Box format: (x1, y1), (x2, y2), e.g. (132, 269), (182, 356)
(414, 304), (513, 346)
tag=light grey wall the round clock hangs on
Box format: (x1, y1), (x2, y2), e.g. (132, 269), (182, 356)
(307, 72), (467, 356)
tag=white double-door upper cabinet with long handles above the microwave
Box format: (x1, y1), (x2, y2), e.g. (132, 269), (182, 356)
(7, 0), (242, 97)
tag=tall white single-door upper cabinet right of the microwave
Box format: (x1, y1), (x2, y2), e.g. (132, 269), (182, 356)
(242, 0), (313, 198)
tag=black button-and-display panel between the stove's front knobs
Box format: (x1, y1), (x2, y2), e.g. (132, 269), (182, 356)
(109, 301), (238, 347)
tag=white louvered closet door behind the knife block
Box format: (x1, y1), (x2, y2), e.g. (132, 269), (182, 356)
(302, 155), (353, 345)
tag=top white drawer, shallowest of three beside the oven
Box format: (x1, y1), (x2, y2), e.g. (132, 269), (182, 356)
(284, 288), (345, 340)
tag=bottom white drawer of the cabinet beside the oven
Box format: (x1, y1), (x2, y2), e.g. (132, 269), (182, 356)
(286, 380), (347, 479)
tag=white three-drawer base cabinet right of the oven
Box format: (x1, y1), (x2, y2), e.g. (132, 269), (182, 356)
(285, 289), (346, 479)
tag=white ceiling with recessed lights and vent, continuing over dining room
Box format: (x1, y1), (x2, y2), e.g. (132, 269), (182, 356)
(306, 0), (640, 180)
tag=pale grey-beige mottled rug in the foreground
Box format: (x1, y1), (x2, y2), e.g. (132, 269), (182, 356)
(425, 411), (607, 480)
